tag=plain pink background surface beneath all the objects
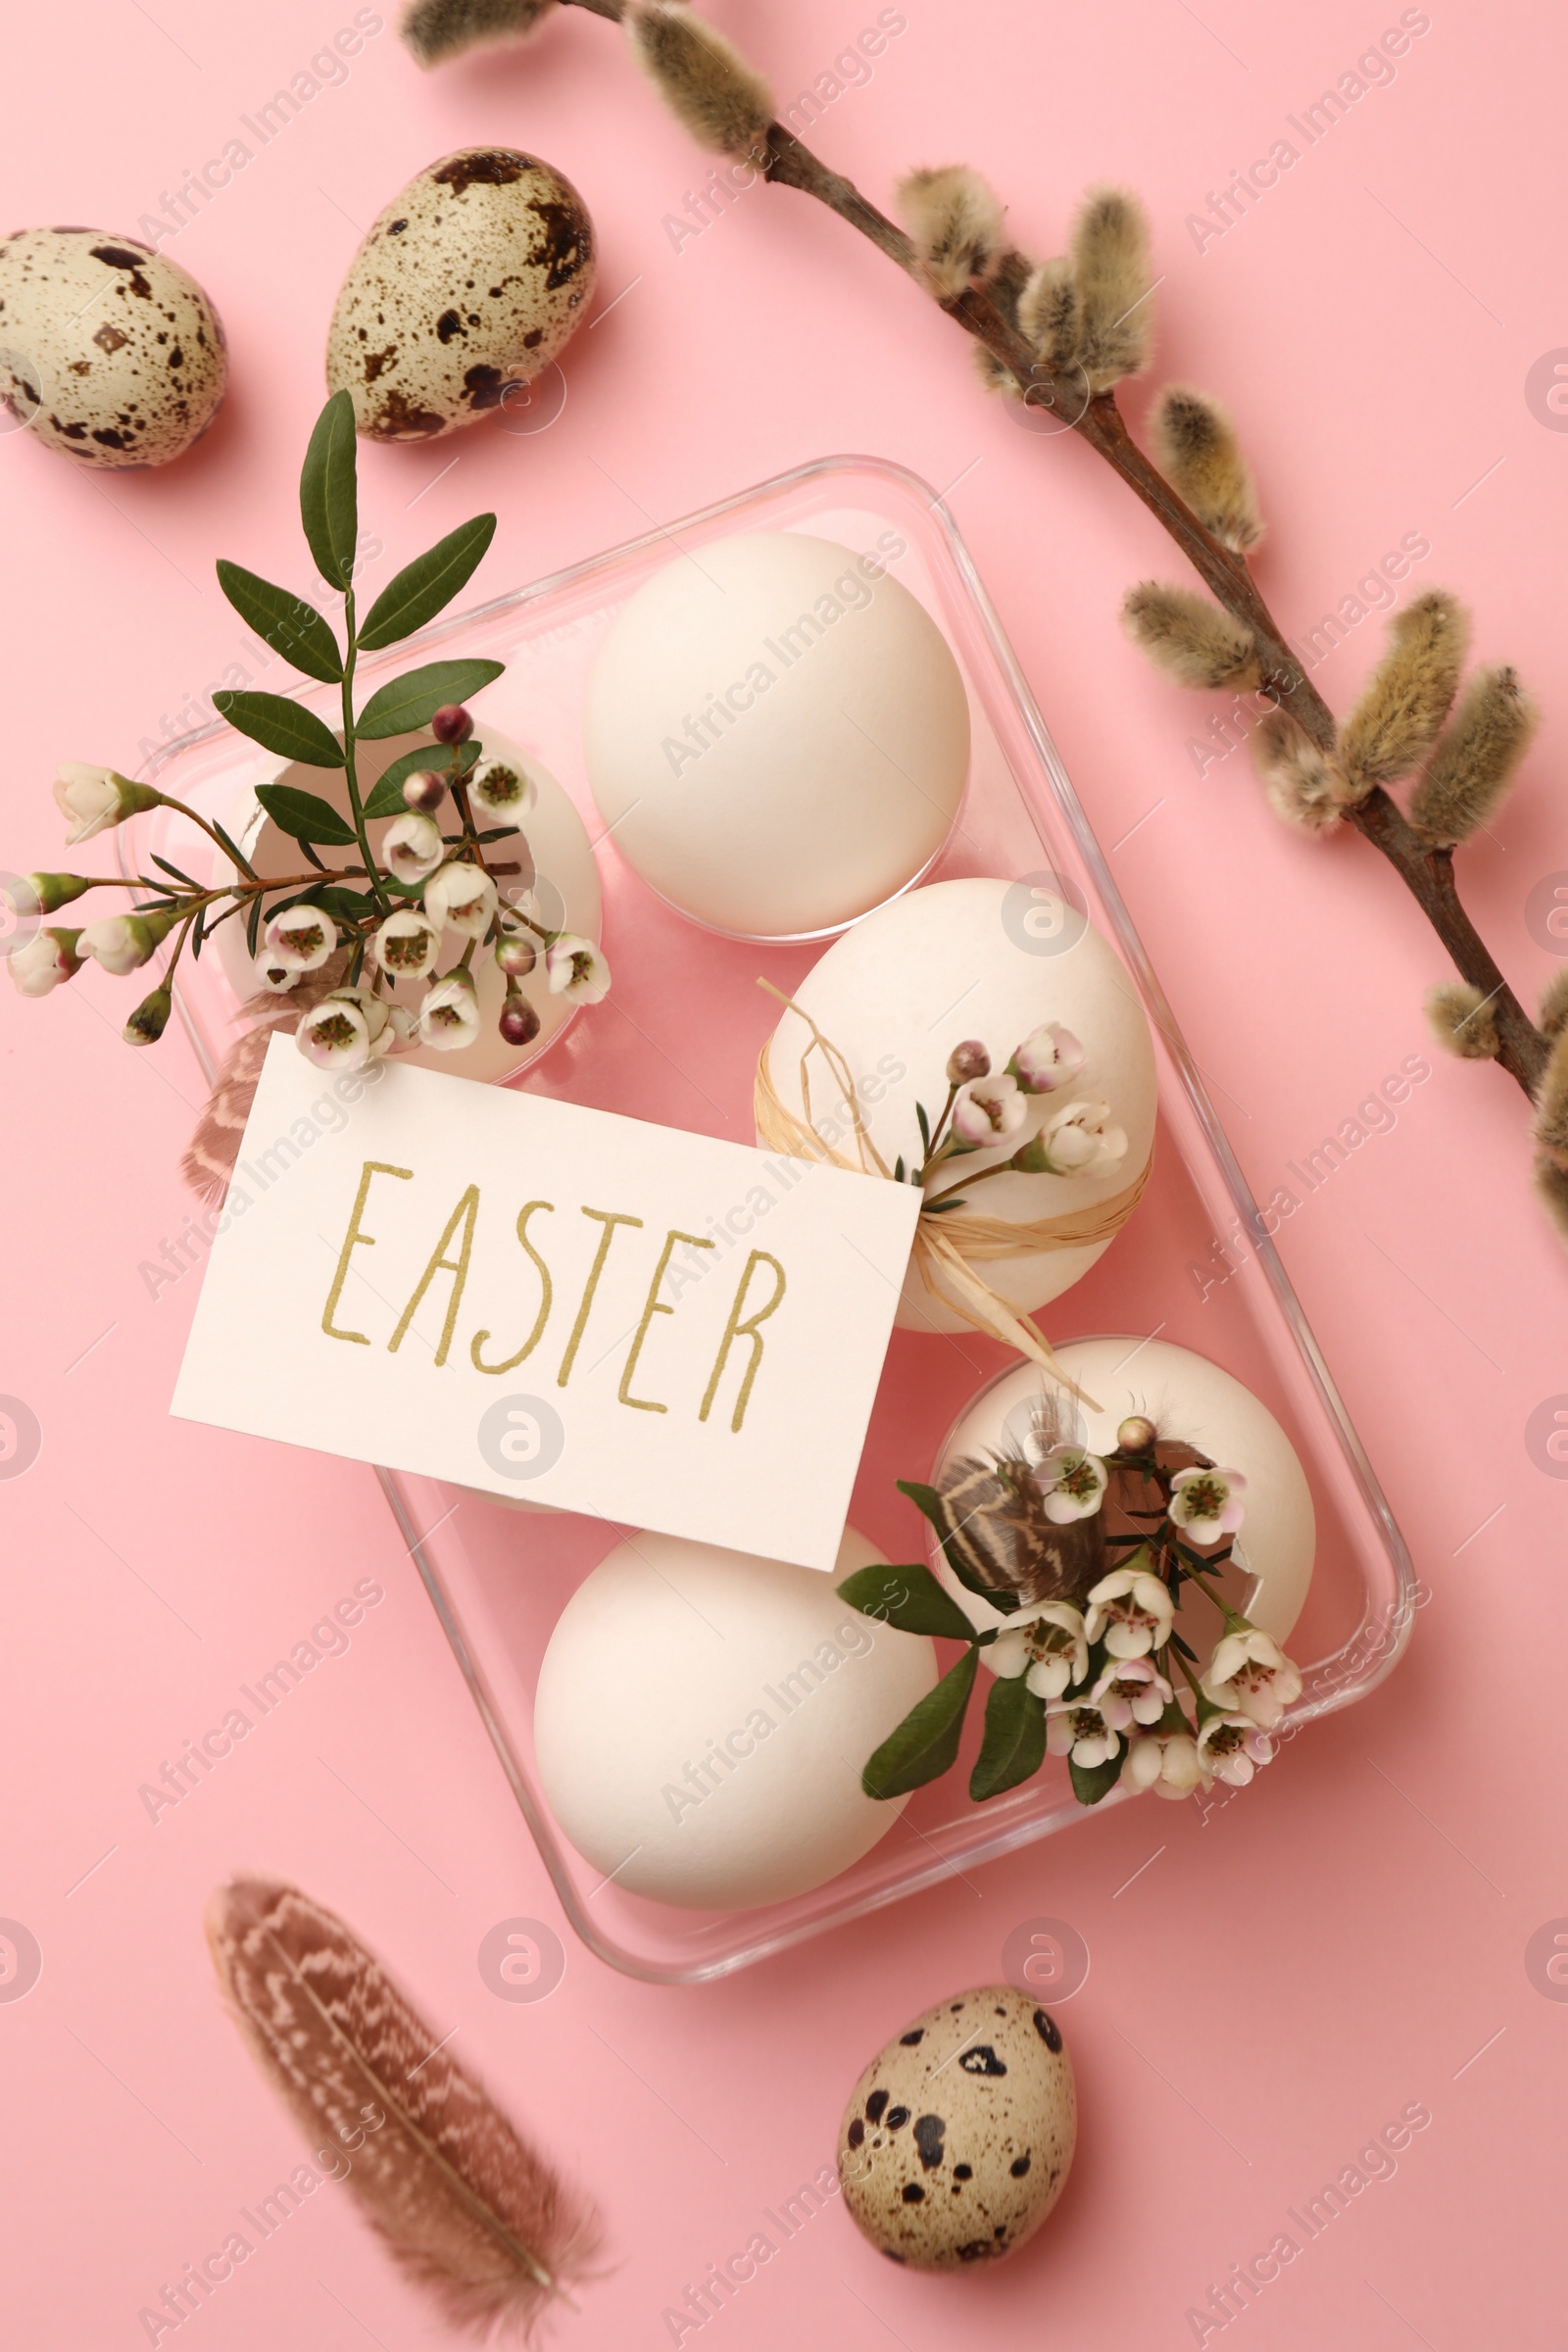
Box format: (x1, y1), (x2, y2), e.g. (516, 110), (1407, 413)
(0, 0), (1568, 2352)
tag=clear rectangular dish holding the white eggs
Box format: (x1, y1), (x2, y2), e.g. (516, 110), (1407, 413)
(124, 457), (1415, 1983)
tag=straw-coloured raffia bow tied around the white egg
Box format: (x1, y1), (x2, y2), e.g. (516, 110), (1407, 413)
(755, 981), (1152, 1411)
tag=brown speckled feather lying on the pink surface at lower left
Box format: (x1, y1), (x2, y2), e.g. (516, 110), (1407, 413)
(207, 1880), (600, 2335)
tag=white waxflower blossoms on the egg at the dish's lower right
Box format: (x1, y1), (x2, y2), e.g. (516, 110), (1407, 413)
(990, 1421), (1302, 1797)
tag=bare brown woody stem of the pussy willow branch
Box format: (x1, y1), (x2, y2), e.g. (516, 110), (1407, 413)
(564, 0), (1546, 1101)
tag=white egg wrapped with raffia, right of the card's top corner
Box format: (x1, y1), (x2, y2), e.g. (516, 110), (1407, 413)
(757, 877), (1156, 1331)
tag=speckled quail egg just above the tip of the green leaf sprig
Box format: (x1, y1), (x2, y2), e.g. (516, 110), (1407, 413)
(326, 148), (595, 440)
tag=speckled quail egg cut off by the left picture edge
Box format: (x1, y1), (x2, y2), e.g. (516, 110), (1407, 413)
(0, 228), (228, 466)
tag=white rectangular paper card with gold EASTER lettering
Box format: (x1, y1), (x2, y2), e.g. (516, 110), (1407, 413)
(172, 1037), (919, 1569)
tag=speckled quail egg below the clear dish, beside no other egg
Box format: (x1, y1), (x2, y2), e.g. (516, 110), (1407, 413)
(839, 1985), (1077, 2270)
